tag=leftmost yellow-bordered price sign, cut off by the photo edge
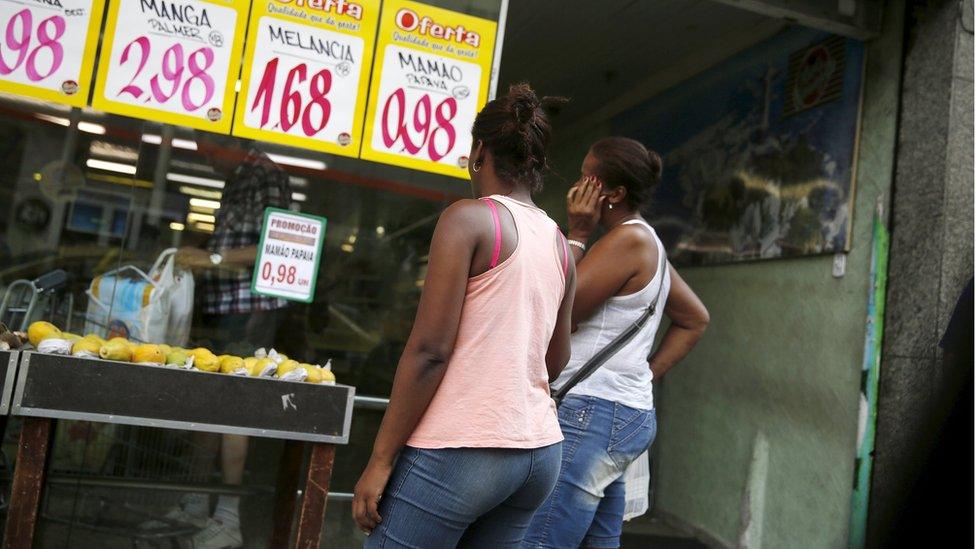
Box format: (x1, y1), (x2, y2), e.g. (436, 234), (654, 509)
(0, 0), (105, 107)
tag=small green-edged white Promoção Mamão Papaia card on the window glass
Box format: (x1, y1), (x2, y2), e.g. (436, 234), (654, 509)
(251, 208), (326, 303)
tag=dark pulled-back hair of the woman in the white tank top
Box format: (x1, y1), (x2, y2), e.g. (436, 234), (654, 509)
(590, 137), (662, 210)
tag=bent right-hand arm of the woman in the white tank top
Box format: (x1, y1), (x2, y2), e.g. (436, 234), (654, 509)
(648, 263), (709, 379)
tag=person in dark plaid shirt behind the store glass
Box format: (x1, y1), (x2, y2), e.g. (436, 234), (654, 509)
(167, 132), (292, 548)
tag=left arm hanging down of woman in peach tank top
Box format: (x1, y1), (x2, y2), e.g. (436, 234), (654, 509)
(353, 200), (484, 533)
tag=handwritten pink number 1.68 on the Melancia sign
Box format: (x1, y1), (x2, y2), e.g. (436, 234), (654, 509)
(251, 57), (332, 137)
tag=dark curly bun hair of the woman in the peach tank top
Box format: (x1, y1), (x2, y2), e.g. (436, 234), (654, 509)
(471, 83), (565, 192)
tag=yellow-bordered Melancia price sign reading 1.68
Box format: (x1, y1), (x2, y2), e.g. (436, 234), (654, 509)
(233, 0), (380, 157)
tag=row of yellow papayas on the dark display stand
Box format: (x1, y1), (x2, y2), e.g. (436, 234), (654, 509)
(22, 321), (336, 385)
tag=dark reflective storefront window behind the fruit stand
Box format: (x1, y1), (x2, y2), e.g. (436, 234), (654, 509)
(0, 0), (500, 547)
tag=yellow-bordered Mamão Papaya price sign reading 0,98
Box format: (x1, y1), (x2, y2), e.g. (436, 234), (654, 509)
(360, 0), (497, 179)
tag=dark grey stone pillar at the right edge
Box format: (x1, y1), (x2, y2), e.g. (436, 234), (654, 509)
(869, 0), (973, 544)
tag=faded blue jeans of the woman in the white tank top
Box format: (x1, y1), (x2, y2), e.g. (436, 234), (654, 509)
(523, 395), (657, 549)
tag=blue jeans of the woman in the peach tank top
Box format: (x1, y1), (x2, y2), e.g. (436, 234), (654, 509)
(364, 443), (562, 549)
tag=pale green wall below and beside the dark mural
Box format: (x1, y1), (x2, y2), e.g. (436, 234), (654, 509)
(542, 2), (903, 547)
